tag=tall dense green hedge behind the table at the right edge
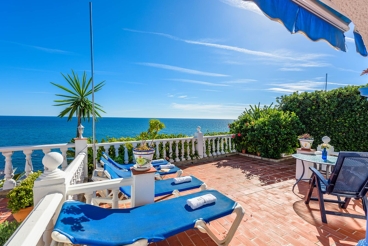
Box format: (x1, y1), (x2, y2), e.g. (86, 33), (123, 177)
(277, 86), (368, 151)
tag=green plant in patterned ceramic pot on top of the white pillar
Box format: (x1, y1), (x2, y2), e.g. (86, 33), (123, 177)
(133, 119), (165, 170)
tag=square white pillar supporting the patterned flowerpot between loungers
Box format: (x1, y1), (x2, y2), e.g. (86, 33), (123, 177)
(131, 167), (156, 207)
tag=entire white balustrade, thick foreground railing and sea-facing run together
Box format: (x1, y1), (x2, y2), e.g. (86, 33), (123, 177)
(0, 128), (235, 246)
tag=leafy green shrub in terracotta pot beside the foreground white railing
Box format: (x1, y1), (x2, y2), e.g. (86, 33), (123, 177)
(6, 171), (41, 222)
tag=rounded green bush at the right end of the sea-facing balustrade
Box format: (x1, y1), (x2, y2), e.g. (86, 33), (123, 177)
(229, 105), (303, 159)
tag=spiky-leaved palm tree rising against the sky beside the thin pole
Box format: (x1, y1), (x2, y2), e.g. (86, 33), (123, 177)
(50, 70), (105, 137)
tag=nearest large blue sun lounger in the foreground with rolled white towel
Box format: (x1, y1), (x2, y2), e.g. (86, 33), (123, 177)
(52, 190), (244, 246)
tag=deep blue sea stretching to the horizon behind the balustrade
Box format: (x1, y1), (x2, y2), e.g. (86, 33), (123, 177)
(0, 116), (234, 176)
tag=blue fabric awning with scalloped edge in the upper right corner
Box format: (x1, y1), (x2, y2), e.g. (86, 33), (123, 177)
(251, 0), (367, 56)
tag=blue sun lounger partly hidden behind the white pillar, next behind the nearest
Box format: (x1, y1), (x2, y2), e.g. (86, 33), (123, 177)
(104, 162), (207, 198)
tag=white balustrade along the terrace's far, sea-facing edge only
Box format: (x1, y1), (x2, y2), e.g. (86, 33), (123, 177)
(0, 134), (235, 190)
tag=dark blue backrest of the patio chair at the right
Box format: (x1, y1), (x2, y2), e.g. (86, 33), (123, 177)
(326, 151), (368, 198)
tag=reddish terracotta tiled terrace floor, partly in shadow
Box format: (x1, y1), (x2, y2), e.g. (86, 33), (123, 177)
(0, 155), (365, 246)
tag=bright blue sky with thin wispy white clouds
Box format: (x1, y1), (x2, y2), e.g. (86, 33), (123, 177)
(0, 0), (368, 119)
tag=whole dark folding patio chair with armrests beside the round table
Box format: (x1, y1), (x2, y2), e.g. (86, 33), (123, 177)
(304, 151), (368, 223)
